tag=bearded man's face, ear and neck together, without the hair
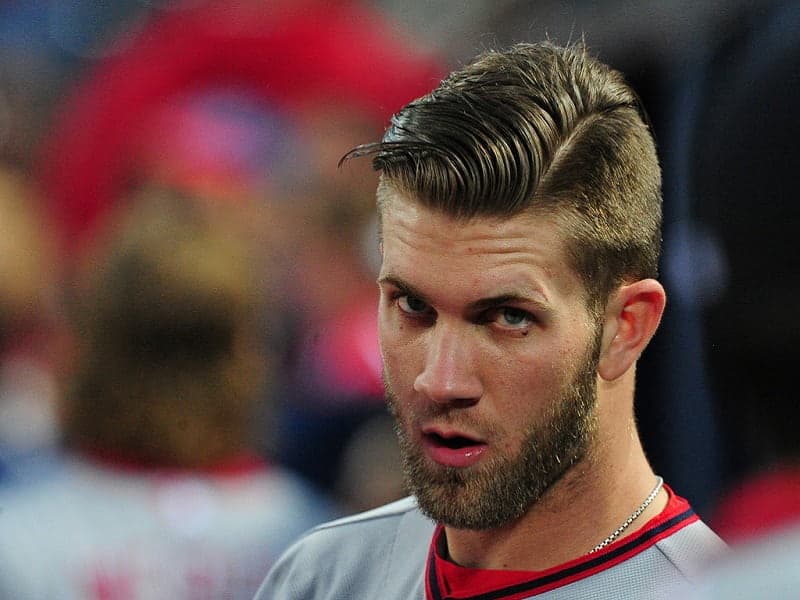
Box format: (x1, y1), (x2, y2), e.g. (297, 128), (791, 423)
(379, 185), (666, 568)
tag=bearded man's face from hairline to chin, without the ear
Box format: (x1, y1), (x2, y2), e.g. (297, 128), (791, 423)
(379, 191), (600, 529)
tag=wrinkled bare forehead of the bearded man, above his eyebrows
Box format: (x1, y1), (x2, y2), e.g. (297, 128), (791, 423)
(381, 190), (584, 300)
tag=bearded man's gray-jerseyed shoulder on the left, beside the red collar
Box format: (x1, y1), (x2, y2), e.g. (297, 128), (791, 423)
(257, 498), (434, 600)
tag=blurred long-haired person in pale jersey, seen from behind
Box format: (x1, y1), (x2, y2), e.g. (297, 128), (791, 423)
(0, 188), (335, 600)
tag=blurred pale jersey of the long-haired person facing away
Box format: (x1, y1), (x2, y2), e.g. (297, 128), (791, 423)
(0, 459), (334, 600)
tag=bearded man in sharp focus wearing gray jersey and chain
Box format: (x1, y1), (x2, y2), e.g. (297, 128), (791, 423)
(258, 43), (724, 600)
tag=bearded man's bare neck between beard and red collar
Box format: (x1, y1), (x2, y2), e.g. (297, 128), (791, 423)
(445, 378), (667, 571)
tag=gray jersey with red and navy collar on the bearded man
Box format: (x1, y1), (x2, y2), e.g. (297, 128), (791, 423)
(256, 494), (725, 600)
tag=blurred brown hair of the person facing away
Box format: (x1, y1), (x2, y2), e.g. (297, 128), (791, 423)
(65, 190), (266, 468)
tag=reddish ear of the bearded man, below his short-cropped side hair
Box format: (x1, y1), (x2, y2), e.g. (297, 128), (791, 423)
(597, 279), (667, 381)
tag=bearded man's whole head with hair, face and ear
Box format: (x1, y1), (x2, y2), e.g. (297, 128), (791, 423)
(347, 43), (663, 529)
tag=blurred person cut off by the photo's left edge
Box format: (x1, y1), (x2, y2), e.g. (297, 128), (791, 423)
(0, 164), (65, 484)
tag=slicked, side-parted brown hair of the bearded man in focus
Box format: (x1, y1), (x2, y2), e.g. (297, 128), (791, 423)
(342, 42), (661, 310)
